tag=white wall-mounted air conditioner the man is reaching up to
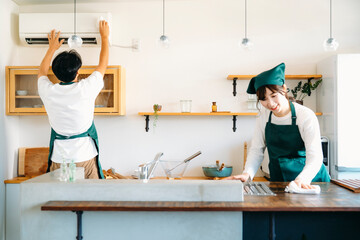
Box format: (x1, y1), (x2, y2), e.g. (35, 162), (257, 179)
(19, 13), (111, 46)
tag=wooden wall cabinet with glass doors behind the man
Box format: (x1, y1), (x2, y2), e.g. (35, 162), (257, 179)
(5, 66), (125, 115)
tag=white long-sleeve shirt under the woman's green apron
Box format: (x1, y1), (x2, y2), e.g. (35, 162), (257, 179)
(244, 103), (323, 184)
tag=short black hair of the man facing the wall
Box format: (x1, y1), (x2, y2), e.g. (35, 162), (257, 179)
(52, 49), (82, 82)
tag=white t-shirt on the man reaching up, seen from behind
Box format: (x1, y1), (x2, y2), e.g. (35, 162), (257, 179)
(38, 71), (104, 163)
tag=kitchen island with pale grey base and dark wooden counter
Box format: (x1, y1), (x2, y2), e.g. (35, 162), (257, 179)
(6, 172), (360, 239)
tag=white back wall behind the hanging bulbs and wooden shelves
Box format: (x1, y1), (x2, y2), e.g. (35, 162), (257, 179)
(2, 0), (360, 180)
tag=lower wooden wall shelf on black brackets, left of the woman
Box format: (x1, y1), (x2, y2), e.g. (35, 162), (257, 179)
(138, 112), (322, 132)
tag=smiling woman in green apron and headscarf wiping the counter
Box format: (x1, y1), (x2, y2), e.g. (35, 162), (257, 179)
(227, 63), (330, 189)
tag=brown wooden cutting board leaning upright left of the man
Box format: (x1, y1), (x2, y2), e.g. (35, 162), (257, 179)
(18, 147), (49, 177)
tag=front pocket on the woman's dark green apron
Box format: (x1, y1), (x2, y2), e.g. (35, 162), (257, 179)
(279, 158), (305, 182)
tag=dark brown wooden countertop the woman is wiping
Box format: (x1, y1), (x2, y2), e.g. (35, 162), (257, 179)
(42, 182), (360, 212)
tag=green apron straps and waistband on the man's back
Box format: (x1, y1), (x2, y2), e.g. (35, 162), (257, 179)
(46, 82), (104, 179)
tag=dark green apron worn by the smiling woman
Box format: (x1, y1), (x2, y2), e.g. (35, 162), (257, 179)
(265, 102), (330, 182)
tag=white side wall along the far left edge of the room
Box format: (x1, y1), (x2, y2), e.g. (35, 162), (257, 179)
(0, 0), (19, 240)
